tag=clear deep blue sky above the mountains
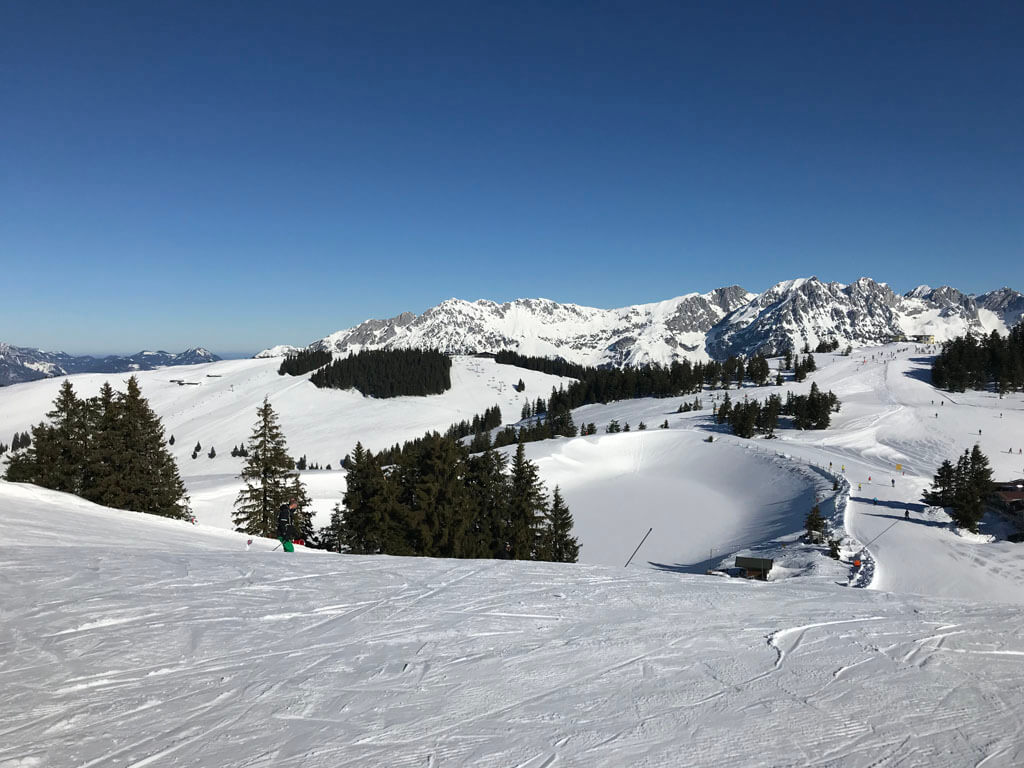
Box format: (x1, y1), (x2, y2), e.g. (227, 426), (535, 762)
(0, 0), (1024, 352)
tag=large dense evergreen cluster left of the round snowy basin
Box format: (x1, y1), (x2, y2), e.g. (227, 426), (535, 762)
(319, 442), (579, 562)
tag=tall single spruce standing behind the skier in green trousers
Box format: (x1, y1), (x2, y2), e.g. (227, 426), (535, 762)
(231, 397), (302, 538)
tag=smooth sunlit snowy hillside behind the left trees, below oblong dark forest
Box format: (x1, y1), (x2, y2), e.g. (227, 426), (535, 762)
(0, 357), (566, 527)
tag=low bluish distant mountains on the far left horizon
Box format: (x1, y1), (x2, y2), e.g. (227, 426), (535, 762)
(0, 342), (220, 387)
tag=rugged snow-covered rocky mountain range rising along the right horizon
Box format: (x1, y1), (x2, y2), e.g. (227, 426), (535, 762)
(256, 278), (1024, 366)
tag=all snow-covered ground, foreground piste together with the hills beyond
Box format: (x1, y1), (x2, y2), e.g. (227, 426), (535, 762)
(0, 345), (1024, 768)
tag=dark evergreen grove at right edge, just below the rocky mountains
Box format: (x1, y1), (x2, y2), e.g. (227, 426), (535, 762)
(932, 324), (1024, 393)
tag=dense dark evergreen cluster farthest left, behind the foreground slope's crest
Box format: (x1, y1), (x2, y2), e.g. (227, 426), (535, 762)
(4, 376), (190, 519)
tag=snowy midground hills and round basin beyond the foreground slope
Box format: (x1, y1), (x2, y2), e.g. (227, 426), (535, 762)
(0, 345), (1024, 602)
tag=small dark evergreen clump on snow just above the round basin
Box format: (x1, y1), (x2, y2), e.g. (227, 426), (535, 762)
(715, 382), (842, 437)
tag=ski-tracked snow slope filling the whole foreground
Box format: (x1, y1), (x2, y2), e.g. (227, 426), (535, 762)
(0, 482), (1024, 768)
